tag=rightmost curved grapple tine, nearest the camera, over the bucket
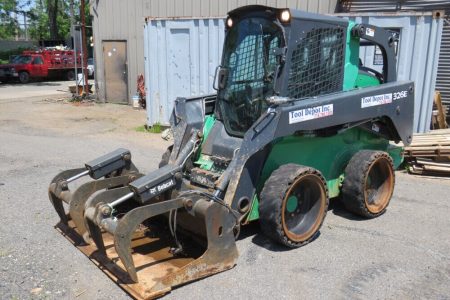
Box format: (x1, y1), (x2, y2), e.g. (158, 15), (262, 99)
(114, 198), (183, 282)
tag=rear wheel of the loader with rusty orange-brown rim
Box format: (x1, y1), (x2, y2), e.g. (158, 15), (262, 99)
(342, 150), (395, 218)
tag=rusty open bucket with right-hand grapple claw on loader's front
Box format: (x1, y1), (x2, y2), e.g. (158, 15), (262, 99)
(58, 193), (238, 299)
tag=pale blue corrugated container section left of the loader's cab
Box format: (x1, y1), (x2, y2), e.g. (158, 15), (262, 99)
(144, 19), (225, 126)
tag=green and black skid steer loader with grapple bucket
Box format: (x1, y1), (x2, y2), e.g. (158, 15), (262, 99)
(49, 6), (414, 299)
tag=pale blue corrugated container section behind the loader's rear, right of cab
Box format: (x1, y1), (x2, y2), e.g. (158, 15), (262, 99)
(338, 12), (443, 132)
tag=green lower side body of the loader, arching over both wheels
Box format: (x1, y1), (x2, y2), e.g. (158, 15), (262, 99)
(246, 127), (402, 222)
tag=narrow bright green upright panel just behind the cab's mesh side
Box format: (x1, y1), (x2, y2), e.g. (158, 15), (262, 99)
(343, 21), (359, 91)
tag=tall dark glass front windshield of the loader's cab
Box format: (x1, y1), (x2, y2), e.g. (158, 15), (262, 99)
(218, 18), (284, 136)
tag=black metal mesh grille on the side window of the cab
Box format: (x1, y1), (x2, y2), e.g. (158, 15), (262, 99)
(288, 28), (344, 99)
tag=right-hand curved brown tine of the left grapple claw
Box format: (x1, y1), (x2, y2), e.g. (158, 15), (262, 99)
(69, 174), (139, 236)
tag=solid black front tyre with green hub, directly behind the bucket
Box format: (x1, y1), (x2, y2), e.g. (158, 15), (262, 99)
(259, 164), (328, 248)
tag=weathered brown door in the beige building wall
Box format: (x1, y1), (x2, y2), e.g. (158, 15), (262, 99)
(103, 41), (128, 104)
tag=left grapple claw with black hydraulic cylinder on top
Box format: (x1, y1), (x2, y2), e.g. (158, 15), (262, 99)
(48, 149), (142, 240)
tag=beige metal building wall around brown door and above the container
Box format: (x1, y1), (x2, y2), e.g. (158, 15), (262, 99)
(90, 0), (337, 103)
